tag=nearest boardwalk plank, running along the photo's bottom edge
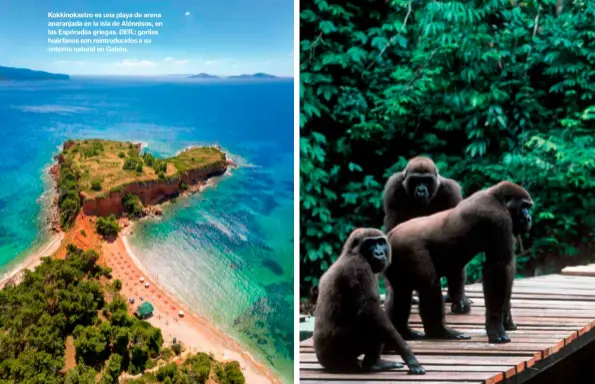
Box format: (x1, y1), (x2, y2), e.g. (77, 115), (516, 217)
(300, 370), (504, 384)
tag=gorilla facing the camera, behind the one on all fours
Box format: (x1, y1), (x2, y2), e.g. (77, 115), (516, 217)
(384, 156), (471, 313)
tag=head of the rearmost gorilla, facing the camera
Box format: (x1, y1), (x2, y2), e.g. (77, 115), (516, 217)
(403, 156), (440, 205)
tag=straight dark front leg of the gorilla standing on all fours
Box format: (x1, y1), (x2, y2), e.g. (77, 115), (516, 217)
(483, 255), (514, 343)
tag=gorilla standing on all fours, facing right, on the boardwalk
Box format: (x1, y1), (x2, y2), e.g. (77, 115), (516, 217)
(385, 181), (533, 343)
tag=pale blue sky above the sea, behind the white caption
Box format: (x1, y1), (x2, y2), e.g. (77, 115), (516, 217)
(0, 0), (294, 76)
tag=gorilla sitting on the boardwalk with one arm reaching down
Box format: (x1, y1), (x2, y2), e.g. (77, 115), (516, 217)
(314, 228), (425, 374)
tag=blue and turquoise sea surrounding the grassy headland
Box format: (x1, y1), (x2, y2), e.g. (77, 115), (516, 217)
(0, 78), (294, 382)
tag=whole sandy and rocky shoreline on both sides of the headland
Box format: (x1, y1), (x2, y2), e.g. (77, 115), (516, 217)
(0, 147), (281, 384)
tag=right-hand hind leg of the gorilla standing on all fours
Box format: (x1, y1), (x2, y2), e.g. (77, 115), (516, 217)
(418, 277), (471, 339)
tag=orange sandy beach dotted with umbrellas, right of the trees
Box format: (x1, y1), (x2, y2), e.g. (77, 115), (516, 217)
(118, 223), (280, 384)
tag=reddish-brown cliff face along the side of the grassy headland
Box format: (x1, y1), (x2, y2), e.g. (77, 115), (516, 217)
(81, 163), (228, 216)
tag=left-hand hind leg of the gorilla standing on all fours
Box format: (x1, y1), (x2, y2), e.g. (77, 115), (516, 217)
(384, 279), (424, 340)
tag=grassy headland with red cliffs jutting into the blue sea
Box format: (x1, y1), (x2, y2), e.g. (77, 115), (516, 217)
(51, 139), (235, 230)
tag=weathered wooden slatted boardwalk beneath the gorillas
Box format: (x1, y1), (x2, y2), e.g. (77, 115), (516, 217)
(300, 272), (595, 384)
